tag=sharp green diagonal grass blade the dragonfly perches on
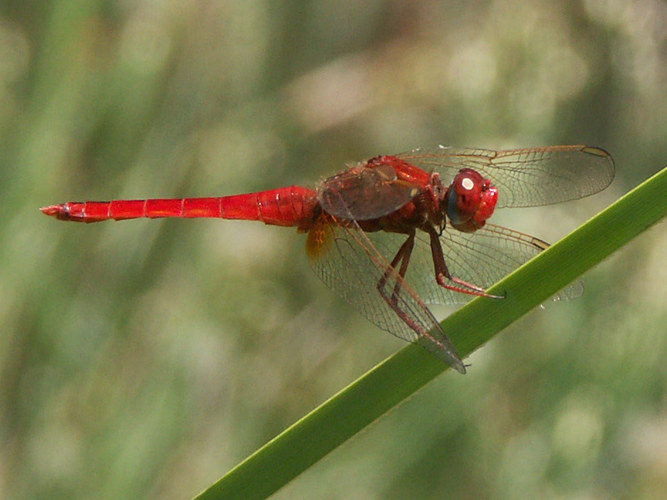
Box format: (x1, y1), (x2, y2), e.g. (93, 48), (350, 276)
(197, 169), (667, 500)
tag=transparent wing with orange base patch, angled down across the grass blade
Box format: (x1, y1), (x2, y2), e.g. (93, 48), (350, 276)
(307, 218), (465, 373)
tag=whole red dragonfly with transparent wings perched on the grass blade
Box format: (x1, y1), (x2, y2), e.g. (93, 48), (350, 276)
(41, 146), (614, 373)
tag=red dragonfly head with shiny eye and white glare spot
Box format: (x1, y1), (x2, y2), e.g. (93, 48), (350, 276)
(445, 168), (498, 233)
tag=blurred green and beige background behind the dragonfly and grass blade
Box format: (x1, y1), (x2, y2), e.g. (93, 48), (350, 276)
(0, 0), (667, 499)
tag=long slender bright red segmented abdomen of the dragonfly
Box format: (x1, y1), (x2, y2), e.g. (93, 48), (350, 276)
(41, 186), (317, 229)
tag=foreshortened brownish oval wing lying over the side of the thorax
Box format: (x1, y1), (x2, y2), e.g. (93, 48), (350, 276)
(318, 165), (420, 220)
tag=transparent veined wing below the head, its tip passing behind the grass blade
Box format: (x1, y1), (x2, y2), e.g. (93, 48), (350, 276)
(408, 224), (583, 304)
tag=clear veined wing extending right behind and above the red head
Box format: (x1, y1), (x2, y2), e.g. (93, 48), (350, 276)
(396, 146), (614, 207)
